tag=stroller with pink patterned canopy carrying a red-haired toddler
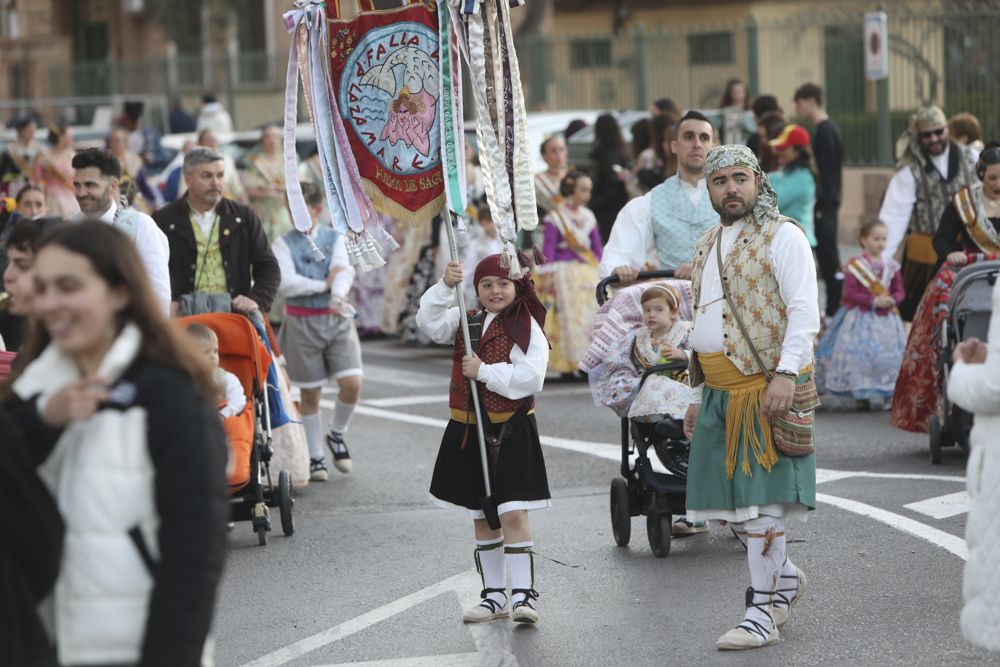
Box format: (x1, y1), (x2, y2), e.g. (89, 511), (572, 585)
(588, 271), (708, 557)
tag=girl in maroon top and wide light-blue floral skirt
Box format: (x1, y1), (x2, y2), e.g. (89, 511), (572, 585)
(816, 222), (906, 409)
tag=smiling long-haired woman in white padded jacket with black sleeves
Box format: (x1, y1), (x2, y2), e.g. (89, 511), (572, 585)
(6, 221), (228, 667)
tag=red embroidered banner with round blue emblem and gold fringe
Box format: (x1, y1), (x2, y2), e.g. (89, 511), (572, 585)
(329, 4), (445, 223)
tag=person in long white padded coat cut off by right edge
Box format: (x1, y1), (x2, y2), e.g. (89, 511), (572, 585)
(948, 285), (1000, 651)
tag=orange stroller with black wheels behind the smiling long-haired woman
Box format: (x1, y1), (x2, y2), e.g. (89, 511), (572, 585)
(178, 313), (295, 545)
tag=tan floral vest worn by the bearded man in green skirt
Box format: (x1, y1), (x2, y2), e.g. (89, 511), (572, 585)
(691, 217), (794, 386)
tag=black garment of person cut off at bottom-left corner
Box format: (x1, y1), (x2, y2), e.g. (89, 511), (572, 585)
(0, 408), (63, 666)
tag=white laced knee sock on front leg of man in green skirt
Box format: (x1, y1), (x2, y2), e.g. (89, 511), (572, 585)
(740, 516), (785, 643)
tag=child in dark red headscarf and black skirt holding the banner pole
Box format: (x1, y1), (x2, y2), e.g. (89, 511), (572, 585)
(417, 218), (551, 623)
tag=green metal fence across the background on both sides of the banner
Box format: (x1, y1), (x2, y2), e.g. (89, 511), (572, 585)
(31, 0), (1000, 165)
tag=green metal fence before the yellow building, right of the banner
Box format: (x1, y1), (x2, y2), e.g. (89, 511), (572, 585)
(518, 0), (1000, 165)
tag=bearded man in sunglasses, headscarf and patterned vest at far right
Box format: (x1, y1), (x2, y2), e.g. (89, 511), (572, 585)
(878, 106), (976, 322)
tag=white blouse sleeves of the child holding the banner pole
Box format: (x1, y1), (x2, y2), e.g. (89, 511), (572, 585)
(417, 280), (549, 400)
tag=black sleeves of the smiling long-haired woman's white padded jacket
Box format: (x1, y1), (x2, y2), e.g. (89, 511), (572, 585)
(6, 358), (229, 667)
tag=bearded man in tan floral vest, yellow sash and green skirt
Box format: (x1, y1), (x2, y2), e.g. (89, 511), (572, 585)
(684, 145), (820, 650)
